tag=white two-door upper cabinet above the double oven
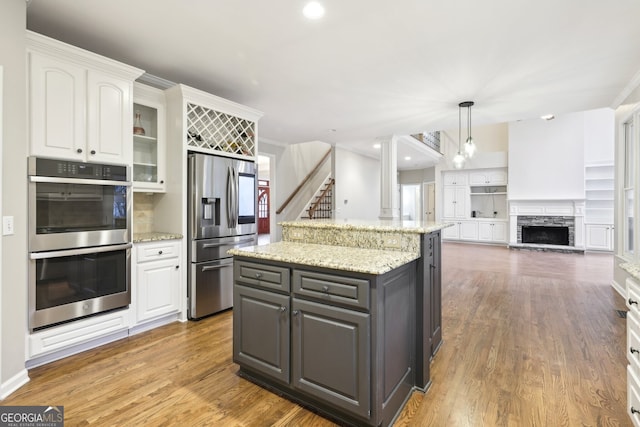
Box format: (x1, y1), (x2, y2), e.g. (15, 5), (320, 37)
(27, 32), (143, 165)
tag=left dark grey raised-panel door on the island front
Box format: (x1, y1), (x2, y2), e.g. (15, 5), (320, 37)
(233, 284), (291, 384)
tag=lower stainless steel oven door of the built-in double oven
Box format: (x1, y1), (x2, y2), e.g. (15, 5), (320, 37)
(29, 243), (132, 331)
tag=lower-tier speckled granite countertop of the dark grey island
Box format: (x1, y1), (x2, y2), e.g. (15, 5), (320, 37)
(228, 242), (419, 274)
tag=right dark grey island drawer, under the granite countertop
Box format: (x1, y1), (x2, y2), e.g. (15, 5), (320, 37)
(293, 270), (370, 310)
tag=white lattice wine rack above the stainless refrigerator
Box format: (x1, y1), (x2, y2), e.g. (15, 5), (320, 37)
(187, 103), (256, 156)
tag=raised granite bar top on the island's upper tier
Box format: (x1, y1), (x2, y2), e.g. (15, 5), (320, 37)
(278, 219), (453, 234)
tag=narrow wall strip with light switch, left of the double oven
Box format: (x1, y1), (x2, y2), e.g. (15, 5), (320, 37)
(0, 0), (28, 399)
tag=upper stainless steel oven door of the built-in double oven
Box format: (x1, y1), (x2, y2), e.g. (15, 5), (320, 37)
(29, 176), (131, 252)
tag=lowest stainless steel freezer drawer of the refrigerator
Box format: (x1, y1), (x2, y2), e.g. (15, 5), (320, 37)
(189, 257), (233, 319)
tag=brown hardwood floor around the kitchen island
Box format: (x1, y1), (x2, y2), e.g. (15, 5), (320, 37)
(0, 243), (631, 426)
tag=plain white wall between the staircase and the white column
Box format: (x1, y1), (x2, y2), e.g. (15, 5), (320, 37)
(335, 148), (380, 219)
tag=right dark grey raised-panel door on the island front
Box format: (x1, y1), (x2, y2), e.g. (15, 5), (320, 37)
(291, 298), (371, 419)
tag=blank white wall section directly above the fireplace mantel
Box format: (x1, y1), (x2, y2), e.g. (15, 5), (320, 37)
(509, 113), (584, 200)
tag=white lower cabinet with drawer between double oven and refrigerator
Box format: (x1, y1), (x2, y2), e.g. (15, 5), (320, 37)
(132, 240), (182, 325)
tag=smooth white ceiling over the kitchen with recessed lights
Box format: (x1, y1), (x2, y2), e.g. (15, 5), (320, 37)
(27, 0), (640, 168)
